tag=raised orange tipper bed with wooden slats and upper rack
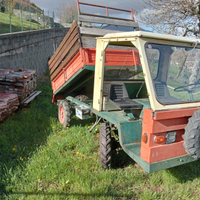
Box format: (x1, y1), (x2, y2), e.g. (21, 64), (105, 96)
(48, 1), (141, 103)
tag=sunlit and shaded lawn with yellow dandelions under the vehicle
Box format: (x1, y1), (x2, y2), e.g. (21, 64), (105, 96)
(0, 76), (200, 200)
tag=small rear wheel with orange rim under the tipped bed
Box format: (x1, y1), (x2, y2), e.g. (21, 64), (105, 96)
(58, 100), (72, 128)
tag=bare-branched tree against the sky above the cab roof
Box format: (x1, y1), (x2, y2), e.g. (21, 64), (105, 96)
(138, 0), (200, 37)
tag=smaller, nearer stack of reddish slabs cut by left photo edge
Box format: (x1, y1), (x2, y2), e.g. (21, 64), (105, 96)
(0, 92), (19, 122)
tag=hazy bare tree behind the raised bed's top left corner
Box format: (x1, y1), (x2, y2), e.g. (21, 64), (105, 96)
(56, 2), (78, 23)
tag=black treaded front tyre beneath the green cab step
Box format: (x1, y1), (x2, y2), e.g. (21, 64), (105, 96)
(100, 123), (112, 169)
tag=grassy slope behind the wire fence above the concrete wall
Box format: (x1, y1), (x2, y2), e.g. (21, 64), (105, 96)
(0, 12), (44, 34)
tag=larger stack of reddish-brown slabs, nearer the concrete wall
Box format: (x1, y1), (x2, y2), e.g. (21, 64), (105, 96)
(0, 69), (36, 101)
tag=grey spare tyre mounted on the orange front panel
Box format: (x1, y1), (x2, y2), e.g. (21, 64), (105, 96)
(183, 110), (200, 159)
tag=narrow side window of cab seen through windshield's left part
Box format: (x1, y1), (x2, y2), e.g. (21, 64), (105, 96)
(146, 44), (160, 79)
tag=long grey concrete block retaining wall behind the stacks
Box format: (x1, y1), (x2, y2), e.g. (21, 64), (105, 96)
(0, 28), (69, 75)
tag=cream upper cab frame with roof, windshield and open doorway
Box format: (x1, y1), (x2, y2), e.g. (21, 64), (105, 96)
(93, 31), (200, 111)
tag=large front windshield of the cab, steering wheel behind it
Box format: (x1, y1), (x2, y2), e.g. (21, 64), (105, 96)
(145, 43), (200, 104)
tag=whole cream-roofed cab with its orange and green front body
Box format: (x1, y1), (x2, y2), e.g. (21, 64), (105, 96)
(93, 31), (200, 173)
